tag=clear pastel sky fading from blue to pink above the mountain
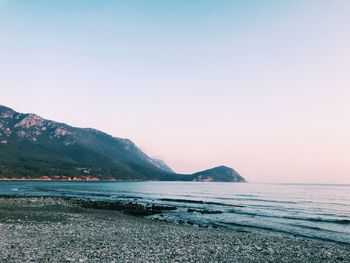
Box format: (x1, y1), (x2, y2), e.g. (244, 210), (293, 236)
(0, 0), (350, 183)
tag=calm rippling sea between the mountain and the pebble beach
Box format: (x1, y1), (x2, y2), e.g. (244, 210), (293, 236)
(0, 181), (350, 244)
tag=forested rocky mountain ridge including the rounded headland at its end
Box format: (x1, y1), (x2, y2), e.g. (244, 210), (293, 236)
(0, 105), (244, 184)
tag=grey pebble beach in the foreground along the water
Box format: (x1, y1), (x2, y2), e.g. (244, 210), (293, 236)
(0, 197), (350, 262)
